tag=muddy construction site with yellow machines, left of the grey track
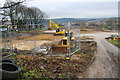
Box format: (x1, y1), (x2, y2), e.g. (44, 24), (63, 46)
(1, 20), (119, 79)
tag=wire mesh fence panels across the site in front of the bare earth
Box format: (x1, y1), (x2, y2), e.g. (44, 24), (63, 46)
(0, 25), (80, 56)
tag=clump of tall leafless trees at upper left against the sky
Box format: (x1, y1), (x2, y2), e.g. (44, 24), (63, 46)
(1, 0), (46, 29)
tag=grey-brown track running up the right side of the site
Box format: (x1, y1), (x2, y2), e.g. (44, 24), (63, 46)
(81, 32), (119, 78)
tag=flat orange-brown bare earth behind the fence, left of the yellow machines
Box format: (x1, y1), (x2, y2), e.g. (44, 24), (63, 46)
(2, 34), (64, 50)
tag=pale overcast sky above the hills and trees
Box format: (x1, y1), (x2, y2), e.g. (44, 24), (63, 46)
(0, 0), (119, 18)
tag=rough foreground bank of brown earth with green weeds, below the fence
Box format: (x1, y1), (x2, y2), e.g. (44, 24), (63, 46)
(16, 54), (92, 79)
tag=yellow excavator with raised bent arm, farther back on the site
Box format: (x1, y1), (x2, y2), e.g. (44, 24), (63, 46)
(48, 20), (65, 35)
